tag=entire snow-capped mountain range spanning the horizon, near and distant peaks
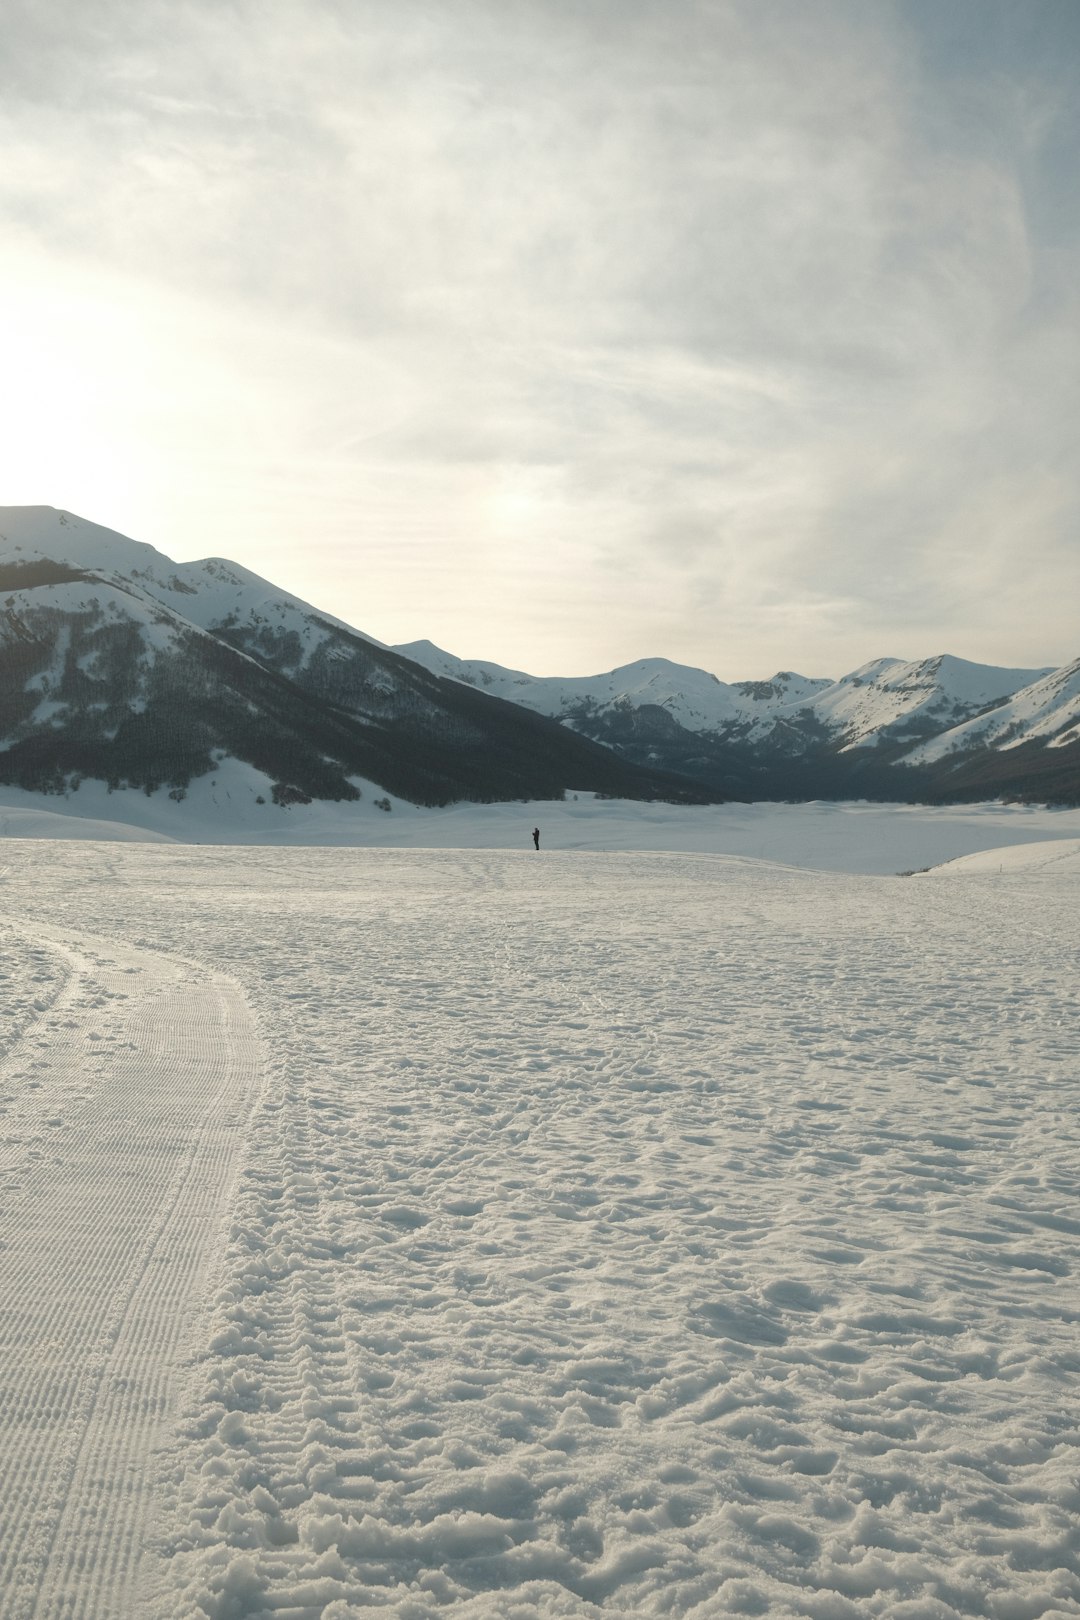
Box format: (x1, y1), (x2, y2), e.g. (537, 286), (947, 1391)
(0, 507), (1080, 804)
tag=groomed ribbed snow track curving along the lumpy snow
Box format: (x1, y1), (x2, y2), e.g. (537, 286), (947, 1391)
(0, 935), (261, 1620)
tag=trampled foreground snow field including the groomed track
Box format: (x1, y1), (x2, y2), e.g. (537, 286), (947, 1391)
(0, 800), (1080, 1620)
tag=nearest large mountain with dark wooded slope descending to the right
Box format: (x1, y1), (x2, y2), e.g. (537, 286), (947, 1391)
(0, 507), (716, 804)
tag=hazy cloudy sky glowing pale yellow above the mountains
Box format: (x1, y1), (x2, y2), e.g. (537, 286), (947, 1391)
(0, 0), (1080, 680)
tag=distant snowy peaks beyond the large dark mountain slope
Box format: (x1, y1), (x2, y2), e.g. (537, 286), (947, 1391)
(397, 642), (1080, 797)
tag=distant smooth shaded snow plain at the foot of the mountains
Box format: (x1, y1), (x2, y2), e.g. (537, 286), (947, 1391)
(0, 760), (1080, 876)
